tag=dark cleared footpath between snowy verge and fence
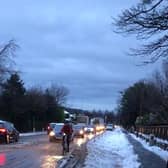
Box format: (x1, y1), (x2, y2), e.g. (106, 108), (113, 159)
(127, 134), (167, 168)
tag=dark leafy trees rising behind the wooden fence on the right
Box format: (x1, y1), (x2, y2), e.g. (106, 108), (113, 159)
(117, 62), (168, 127)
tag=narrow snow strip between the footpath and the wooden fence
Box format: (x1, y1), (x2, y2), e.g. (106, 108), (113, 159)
(131, 134), (168, 161)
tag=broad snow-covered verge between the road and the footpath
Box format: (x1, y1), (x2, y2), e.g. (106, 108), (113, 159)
(85, 128), (140, 168)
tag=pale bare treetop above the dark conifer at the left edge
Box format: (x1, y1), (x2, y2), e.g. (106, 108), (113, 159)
(0, 40), (18, 83)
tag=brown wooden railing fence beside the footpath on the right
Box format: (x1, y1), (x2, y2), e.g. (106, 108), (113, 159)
(136, 125), (168, 140)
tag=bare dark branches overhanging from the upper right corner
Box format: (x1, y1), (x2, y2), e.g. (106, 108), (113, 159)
(114, 0), (168, 63)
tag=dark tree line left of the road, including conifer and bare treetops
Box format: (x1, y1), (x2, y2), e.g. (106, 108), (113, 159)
(0, 40), (68, 132)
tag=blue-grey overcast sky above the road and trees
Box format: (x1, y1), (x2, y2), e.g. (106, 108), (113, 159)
(0, 0), (161, 110)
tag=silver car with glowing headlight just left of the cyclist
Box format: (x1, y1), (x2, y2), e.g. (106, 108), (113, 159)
(49, 123), (64, 142)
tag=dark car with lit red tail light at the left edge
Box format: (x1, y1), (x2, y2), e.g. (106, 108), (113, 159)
(0, 120), (19, 144)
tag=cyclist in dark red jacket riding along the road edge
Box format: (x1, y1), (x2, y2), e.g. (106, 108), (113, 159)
(61, 120), (73, 152)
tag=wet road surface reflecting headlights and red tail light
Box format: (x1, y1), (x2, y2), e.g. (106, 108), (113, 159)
(0, 135), (93, 168)
